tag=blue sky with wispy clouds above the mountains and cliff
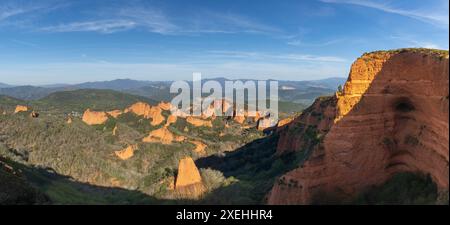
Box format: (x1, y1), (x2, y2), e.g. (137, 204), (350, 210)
(0, 0), (449, 85)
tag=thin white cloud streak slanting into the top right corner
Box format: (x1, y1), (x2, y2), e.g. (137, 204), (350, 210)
(319, 0), (449, 28)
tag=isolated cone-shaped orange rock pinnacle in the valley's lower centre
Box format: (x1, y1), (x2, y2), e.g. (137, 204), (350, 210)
(175, 157), (206, 199)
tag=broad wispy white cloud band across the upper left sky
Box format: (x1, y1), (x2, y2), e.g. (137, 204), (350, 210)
(0, 0), (279, 35)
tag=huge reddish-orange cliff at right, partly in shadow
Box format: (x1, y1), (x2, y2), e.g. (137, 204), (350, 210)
(268, 49), (449, 204)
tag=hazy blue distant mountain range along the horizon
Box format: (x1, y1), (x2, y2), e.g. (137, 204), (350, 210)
(0, 78), (345, 104)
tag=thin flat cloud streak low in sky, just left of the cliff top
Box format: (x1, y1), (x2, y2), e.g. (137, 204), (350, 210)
(209, 51), (347, 63)
